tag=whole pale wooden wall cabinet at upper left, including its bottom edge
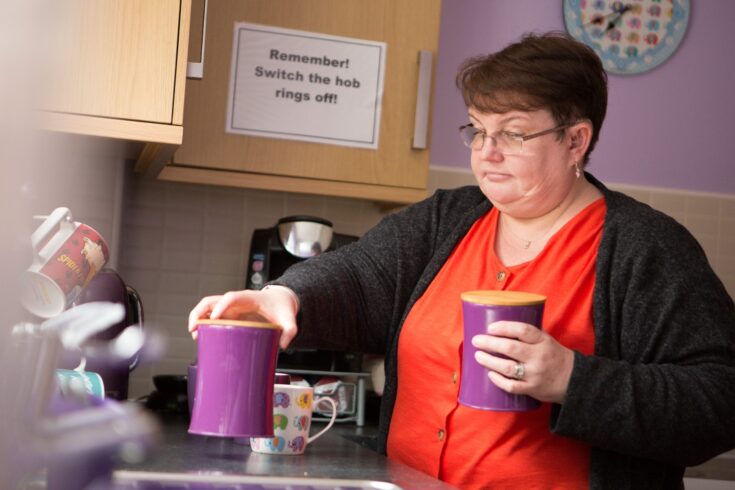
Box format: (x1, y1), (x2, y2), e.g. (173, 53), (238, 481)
(43, 0), (191, 145)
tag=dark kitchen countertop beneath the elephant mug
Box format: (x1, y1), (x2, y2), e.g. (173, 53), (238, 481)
(118, 415), (454, 490)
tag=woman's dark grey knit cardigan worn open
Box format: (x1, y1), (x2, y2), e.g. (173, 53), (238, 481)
(273, 174), (735, 490)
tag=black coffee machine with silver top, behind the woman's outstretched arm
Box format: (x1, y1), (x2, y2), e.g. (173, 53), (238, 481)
(245, 215), (362, 371)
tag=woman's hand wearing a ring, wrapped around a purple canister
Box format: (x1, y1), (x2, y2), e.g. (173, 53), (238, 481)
(472, 321), (574, 403)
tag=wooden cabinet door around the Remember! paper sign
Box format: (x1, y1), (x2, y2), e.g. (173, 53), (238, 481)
(170, 0), (441, 200)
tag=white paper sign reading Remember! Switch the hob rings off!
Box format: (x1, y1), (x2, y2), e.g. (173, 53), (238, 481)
(226, 23), (386, 149)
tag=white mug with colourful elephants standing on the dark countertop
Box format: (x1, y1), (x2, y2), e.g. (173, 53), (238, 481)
(250, 385), (337, 455)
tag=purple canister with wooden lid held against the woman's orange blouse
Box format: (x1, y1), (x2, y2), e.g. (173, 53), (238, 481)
(459, 291), (546, 412)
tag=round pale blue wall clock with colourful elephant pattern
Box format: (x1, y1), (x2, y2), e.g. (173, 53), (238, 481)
(564, 0), (689, 74)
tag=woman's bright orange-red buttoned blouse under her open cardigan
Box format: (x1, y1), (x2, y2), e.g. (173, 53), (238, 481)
(388, 199), (606, 489)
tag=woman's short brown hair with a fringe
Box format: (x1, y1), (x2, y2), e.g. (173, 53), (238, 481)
(456, 32), (607, 167)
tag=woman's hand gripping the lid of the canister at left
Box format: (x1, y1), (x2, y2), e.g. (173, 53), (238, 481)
(189, 286), (299, 349)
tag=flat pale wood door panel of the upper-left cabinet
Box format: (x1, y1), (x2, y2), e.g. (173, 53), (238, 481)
(46, 0), (188, 124)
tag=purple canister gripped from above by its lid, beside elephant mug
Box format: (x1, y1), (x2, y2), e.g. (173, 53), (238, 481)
(189, 320), (281, 437)
